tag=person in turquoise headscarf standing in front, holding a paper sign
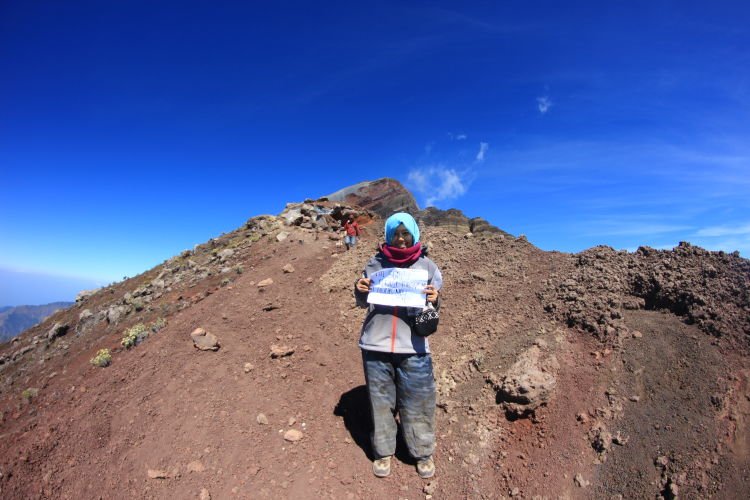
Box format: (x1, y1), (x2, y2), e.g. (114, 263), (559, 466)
(354, 212), (443, 478)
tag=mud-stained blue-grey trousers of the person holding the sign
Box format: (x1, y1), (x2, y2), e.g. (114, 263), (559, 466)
(362, 350), (435, 460)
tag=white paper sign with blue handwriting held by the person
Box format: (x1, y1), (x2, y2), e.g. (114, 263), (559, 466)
(367, 267), (428, 308)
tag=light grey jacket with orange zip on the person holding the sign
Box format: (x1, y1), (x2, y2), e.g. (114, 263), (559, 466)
(354, 252), (443, 354)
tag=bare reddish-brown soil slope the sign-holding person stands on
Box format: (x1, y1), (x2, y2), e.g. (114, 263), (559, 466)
(0, 216), (750, 499)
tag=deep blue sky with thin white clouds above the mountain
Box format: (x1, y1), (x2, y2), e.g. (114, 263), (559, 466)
(0, 0), (750, 305)
